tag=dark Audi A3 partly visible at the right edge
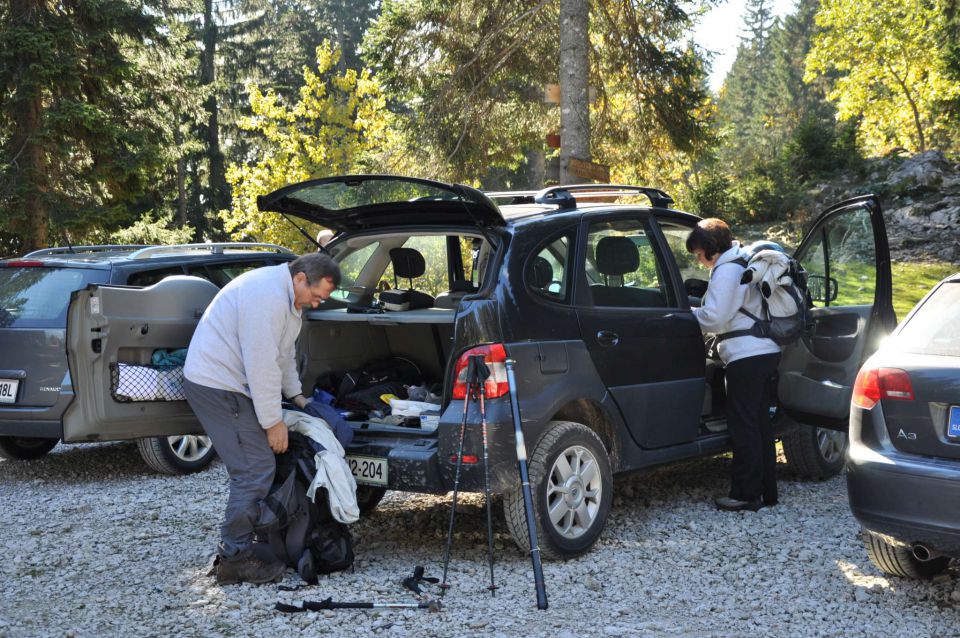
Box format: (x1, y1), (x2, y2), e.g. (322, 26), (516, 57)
(847, 274), (960, 578)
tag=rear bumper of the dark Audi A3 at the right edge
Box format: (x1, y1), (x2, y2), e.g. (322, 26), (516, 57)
(847, 442), (960, 557)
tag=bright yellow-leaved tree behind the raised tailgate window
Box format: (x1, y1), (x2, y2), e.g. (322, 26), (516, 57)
(220, 43), (394, 246)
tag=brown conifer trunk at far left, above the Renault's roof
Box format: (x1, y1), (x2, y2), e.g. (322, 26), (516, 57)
(4, 0), (49, 251)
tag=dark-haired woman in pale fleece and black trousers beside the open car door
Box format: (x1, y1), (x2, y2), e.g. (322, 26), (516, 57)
(686, 218), (780, 511)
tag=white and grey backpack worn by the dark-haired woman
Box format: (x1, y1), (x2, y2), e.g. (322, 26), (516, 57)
(717, 242), (813, 346)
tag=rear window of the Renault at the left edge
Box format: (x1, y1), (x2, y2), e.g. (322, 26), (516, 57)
(0, 267), (110, 328)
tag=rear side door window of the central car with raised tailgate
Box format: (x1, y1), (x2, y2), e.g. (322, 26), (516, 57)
(584, 219), (672, 308)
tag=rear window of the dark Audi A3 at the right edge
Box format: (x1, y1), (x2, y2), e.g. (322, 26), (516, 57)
(896, 282), (960, 357)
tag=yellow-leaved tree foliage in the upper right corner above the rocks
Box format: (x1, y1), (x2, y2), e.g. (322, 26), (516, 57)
(805, 0), (960, 152)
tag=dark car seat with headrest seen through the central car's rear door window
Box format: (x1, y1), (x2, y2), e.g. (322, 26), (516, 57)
(590, 235), (666, 308)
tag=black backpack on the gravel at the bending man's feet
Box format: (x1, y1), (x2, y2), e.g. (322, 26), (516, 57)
(255, 432), (353, 584)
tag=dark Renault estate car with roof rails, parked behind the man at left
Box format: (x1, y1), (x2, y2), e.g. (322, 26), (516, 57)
(0, 243), (296, 474)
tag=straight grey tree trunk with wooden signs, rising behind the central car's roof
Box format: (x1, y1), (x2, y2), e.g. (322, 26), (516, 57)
(560, 0), (590, 184)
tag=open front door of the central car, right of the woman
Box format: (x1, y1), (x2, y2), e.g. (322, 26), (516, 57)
(778, 195), (896, 430)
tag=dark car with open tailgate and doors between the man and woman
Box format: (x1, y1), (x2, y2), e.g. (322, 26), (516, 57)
(52, 175), (893, 557)
